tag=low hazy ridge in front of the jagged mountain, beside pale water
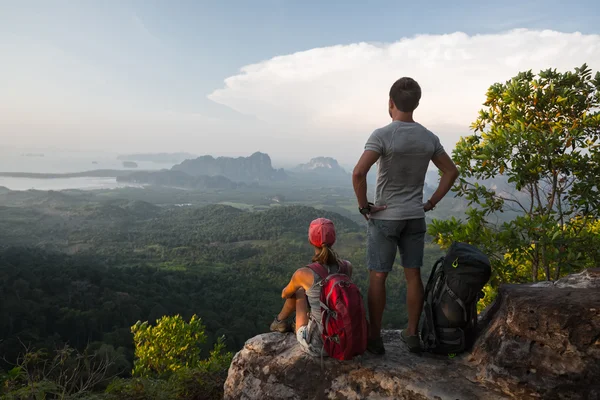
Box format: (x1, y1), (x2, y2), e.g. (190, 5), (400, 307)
(117, 169), (243, 189)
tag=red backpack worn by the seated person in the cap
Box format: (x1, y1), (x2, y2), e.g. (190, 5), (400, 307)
(308, 261), (367, 360)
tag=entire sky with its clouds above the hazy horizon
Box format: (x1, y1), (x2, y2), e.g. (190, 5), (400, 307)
(0, 0), (600, 164)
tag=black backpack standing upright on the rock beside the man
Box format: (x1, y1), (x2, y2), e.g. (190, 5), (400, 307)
(420, 242), (492, 354)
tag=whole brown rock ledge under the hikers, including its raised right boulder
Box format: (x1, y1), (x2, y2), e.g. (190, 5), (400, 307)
(225, 269), (600, 400)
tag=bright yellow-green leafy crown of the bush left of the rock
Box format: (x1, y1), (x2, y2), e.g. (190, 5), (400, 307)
(131, 315), (231, 377)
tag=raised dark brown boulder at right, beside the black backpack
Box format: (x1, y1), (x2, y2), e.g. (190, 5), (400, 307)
(469, 268), (600, 399)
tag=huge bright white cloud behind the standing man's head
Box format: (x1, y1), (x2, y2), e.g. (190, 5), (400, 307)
(208, 29), (600, 155)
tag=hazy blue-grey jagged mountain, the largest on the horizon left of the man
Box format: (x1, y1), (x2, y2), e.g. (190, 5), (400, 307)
(171, 152), (287, 182)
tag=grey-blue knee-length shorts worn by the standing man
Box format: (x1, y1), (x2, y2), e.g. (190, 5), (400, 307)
(367, 218), (427, 272)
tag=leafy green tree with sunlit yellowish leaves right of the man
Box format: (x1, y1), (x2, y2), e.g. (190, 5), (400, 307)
(430, 65), (600, 300)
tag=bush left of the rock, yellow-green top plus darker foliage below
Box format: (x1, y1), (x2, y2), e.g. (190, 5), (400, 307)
(97, 315), (232, 400)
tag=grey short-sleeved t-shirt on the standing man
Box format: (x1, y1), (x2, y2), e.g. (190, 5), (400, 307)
(365, 121), (444, 220)
